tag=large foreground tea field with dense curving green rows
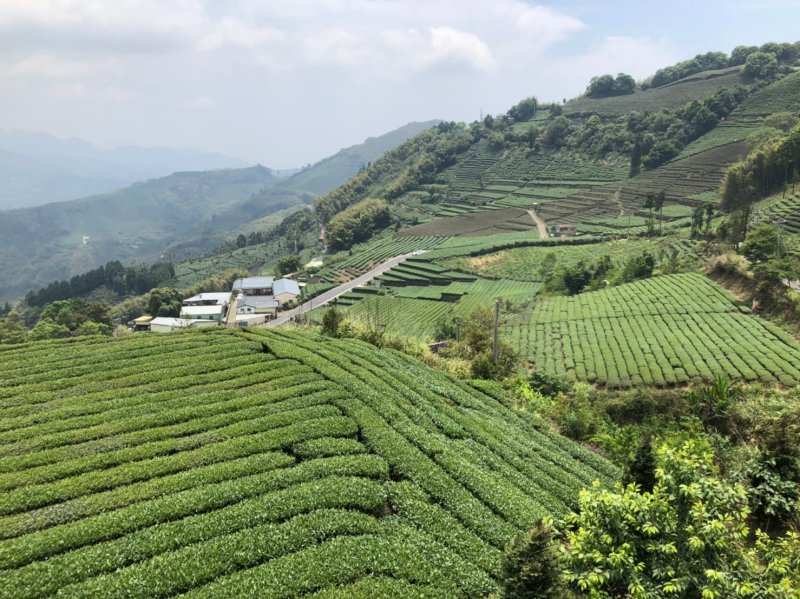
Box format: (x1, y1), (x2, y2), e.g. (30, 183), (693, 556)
(0, 332), (617, 598)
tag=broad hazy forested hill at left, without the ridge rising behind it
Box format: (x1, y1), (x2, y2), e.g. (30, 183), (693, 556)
(0, 166), (294, 297)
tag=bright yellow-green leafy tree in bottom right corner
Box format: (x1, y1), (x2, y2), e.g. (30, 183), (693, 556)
(564, 441), (798, 598)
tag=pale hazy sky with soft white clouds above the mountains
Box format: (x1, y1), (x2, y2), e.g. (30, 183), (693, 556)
(0, 0), (800, 168)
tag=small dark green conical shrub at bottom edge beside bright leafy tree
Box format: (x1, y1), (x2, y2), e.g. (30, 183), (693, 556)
(501, 520), (563, 599)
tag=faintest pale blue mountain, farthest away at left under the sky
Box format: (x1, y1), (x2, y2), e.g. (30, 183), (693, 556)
(0, 131), (245, 210)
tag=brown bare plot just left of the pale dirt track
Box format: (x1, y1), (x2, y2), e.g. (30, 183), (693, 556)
(402, 208), (536, 237)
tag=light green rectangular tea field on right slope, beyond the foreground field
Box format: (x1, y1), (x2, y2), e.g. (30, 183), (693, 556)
(506, 274), (800, 388)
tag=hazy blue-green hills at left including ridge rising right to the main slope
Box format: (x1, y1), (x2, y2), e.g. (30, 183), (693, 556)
(0, 123), (440, 300)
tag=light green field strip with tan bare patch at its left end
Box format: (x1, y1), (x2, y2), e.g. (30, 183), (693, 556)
(442, 239), (695, 281)
